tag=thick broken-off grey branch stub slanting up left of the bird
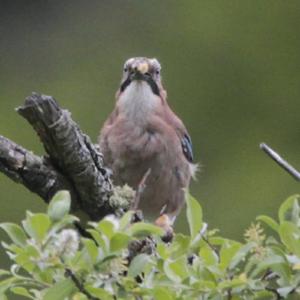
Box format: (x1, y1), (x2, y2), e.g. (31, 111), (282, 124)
(17, 93), (112, 220)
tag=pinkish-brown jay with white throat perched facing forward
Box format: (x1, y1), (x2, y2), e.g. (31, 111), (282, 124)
(99, 57), (197, 230)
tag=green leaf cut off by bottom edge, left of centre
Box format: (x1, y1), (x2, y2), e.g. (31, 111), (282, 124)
(43, 279), (76, 300)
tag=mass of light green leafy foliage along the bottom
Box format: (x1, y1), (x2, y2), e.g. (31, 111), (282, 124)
(0, 192), (300, 300)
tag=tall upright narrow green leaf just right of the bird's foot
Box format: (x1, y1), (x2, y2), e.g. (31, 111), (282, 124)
(186, 194), (203, 239)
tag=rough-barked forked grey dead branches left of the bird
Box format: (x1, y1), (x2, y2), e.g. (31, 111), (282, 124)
(0, 93), (116, 220)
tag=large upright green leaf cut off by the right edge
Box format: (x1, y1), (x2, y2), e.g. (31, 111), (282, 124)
(279, 222), (300, 257)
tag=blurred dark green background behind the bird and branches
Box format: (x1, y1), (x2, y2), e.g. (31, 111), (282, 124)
(0, 0), (300, 267)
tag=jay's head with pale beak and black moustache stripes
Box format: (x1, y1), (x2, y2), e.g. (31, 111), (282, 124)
(119, 57), (164, 96)
